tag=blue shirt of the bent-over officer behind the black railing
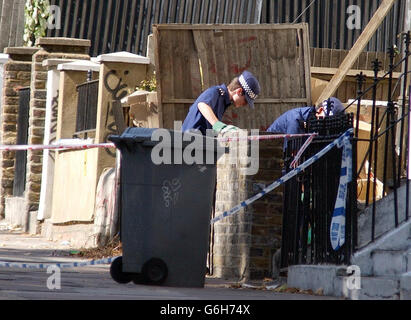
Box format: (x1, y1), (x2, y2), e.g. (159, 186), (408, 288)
(267, 107), (315, 134)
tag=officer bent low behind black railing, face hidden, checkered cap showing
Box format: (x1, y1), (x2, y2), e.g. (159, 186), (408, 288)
(267, 97), (344, 134)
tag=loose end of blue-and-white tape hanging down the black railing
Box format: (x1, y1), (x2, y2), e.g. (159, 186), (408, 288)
(330, 132), (352, 251)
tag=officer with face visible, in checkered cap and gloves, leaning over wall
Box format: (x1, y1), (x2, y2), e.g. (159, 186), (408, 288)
(182, 71), (260, 135)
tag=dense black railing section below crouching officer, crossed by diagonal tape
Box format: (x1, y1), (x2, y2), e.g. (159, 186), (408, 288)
(281, 114), (356, 268)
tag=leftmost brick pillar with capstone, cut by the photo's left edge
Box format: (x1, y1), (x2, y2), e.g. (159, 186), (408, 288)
(0, 47), (38, 217)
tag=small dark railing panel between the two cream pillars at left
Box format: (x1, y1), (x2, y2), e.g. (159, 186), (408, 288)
(74, 75), (99, 138)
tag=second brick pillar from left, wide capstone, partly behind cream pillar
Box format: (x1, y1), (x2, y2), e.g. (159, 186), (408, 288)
(25, 38), (90, 212)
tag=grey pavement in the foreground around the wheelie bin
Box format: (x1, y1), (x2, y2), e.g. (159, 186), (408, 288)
(0, 220), (340, 301)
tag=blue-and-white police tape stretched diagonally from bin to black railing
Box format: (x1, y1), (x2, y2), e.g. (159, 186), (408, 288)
(210, 129), (353, 224)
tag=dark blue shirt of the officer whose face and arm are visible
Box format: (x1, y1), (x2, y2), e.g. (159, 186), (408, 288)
(182, 84), (231, 135)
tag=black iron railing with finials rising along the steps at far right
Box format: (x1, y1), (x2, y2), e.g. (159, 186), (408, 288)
(347, 32), (411, 241)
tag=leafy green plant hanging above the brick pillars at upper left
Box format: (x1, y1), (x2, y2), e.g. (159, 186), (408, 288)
(23, 0), (50, 47)
